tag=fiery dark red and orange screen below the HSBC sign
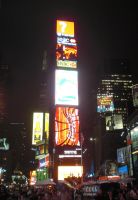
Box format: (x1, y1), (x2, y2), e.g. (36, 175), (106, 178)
(56, 44), (77, 61)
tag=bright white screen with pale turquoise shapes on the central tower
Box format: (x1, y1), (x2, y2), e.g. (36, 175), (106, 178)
(55, 70), (78, 106)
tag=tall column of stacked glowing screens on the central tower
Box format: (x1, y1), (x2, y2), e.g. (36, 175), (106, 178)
(55, 20), (82, 180)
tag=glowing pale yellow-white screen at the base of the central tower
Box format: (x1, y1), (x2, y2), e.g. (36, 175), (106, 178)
(58, 166), (83, 180)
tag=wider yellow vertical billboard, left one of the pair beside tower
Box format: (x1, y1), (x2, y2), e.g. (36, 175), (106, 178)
(32, 113), (43, 145)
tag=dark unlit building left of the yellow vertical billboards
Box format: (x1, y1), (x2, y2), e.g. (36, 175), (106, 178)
(9, 122), (31, 176)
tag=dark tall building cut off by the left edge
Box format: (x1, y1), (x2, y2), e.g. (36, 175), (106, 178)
(0, 64), (11, 183)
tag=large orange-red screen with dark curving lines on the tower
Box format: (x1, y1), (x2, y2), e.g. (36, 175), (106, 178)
(55, 107), (80, 146)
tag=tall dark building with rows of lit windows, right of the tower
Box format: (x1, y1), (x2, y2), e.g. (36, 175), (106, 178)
(97, 59), (133, 167)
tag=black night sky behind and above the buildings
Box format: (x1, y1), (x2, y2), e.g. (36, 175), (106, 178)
(0, 0), (138, 131)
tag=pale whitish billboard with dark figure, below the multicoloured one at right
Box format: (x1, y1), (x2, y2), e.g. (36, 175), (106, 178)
(106, 114), (123, 131)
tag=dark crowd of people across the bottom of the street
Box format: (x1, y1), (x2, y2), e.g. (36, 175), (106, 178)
(0, 180), (138, 200)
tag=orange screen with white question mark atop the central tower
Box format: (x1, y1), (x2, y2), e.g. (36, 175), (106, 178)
(56, 20), (74, 37)
